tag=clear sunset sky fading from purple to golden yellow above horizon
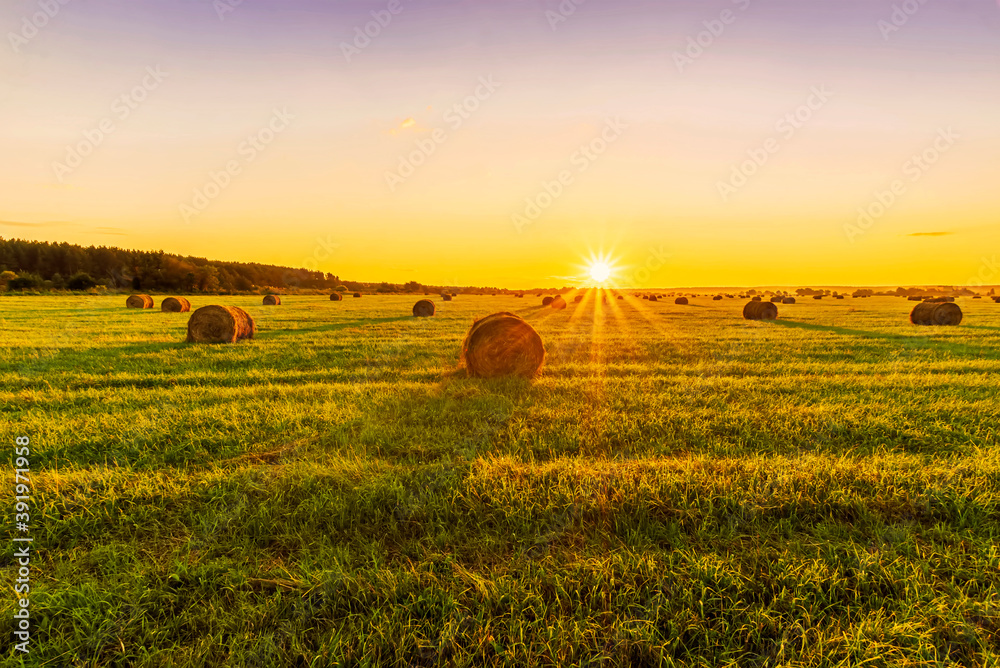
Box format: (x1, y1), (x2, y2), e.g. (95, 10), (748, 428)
(0, 0), (1000, 288)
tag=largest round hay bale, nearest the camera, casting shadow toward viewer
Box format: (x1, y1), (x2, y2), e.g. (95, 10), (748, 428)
(461, 311), (545, 378)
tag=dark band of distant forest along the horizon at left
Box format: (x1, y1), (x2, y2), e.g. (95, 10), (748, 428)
(0, 237), (505, 294)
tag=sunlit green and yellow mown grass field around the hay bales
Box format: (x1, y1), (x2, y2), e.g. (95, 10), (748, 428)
(0, 295), (1000, 668)
